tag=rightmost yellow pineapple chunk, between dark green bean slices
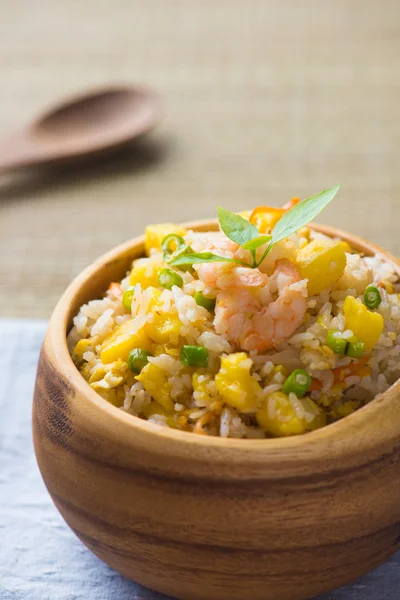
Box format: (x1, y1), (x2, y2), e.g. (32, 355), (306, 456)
(343, 296), (384, 351)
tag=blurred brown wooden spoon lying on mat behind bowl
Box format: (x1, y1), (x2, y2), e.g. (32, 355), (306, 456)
(0, 87), (161, 172)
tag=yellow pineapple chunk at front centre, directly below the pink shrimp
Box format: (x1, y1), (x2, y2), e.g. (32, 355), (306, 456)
(215, 352), (262, 412)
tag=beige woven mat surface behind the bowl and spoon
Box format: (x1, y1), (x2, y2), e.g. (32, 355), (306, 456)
(0, 0), (400, 317)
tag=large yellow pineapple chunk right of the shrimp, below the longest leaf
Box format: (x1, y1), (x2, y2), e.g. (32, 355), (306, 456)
(296, 239), (346, 296)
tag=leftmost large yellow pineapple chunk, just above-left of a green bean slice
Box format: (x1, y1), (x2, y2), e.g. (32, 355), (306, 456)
(100, 319), (150, 365)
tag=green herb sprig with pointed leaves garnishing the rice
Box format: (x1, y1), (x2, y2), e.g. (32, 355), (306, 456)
(168, 185), (340, 269)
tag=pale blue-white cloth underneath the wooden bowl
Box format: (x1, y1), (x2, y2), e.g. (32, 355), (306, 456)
(0, 319), (400, 600)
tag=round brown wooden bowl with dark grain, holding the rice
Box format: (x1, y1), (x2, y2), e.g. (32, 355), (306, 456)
(33, 222), (400, 600)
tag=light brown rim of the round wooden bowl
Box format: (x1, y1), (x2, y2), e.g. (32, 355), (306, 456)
(46, 219), (400, 458)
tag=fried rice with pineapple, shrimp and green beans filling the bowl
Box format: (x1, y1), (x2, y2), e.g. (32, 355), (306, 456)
(68, 209), (400, 438)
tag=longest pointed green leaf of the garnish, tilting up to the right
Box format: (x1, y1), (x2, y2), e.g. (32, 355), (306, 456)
(269, 185), (340, 248)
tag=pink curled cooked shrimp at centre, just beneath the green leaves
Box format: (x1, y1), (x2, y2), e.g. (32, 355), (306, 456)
(214, 259), (307, 352)
